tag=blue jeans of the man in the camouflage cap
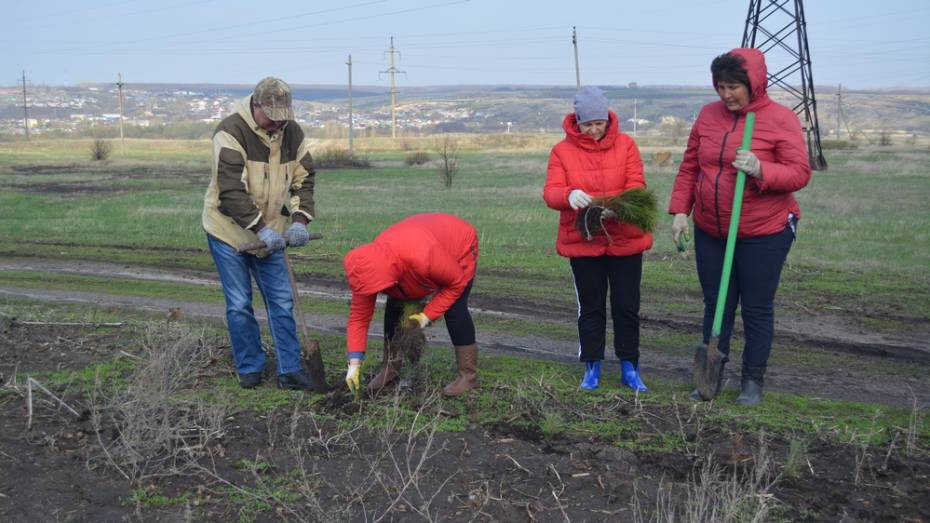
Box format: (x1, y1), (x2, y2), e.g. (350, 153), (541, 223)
(207, 235), (301, 375)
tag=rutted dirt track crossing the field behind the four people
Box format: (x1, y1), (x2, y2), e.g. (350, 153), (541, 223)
(0, 257), (930, 407)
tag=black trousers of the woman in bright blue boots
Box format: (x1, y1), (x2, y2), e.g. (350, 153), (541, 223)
(570, 254), (643, 363)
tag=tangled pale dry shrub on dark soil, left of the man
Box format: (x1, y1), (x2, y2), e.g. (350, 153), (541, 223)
(91, 323), (226, 483)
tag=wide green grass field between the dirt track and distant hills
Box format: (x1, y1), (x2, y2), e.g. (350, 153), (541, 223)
(0, 137), (930, 319)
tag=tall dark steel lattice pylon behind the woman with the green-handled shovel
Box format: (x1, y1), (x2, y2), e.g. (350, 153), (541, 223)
(742, 0), (827, 170)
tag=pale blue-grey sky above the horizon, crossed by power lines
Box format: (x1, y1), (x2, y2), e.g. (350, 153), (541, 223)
(0, 0), (930, 89)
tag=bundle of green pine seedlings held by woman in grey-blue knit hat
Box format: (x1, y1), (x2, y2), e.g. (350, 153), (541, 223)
(575, 187), (659, 240)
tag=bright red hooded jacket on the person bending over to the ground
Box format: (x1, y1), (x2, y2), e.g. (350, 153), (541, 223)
(343, 213), (478, 353)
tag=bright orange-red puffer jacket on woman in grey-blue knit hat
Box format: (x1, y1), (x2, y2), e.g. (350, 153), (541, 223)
(543, 111), (652, 258)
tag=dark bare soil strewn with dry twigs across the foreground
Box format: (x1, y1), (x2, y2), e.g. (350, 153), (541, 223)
(0, 323), (930, 521)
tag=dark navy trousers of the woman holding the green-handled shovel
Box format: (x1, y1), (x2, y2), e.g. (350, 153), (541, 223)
(694, 224), (795, 374)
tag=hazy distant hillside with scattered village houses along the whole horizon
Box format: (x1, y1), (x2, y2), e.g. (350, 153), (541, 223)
(0, 84), (930, 141)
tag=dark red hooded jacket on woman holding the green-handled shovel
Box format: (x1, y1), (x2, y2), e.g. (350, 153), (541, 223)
(668, 49), (811, 238)
